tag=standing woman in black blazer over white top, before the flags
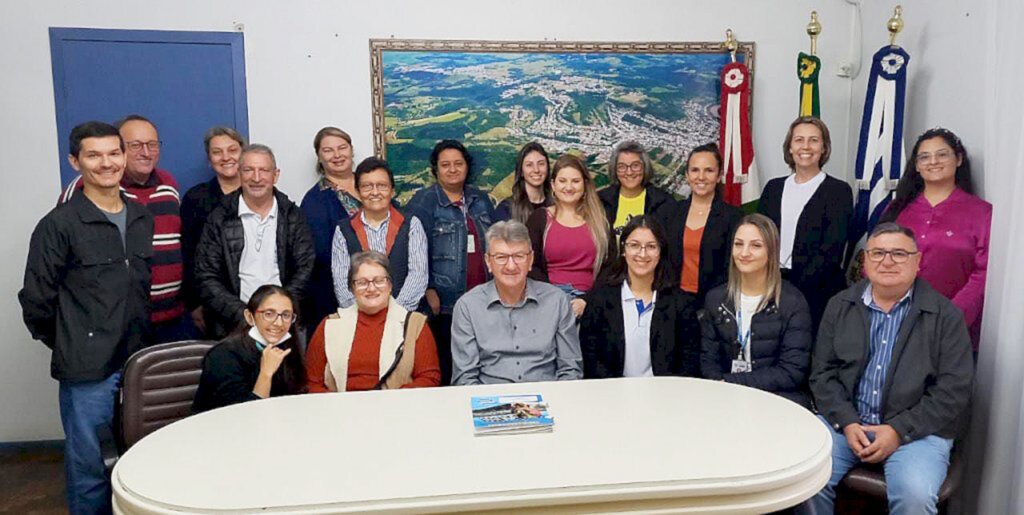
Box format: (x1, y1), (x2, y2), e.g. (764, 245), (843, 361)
(758, 117), (853, 330)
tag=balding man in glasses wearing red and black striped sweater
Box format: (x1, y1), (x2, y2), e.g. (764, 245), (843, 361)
(60, 115), (190, 343)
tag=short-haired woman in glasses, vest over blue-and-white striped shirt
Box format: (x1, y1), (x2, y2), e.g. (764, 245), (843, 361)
(331, 157), (427, 311)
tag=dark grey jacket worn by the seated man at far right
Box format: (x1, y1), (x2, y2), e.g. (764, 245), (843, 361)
(810, 277), (974, 443)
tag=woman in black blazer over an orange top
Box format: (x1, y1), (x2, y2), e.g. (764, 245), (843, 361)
(656, 143), (743, 305)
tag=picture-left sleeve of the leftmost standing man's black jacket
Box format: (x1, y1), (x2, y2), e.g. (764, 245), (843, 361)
(17, 218), (69, 348)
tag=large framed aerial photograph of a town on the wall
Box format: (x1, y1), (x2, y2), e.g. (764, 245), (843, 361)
(370, 39), (755, 202)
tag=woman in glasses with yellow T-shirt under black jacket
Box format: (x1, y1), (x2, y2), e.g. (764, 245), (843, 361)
(597, 141), (674, 238)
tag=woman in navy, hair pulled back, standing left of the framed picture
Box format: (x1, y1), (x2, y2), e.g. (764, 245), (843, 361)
(302, 127), (362, 334)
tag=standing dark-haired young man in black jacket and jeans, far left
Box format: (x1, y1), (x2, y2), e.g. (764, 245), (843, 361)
(17, 122), (153, 514)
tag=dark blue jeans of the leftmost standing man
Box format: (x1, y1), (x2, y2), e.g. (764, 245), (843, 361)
(60, 372), (121, 515)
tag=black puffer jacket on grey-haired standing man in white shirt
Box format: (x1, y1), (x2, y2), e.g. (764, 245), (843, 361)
(196, 189), (315, 338)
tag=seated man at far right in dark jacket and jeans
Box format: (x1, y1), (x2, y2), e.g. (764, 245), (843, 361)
(798, 222), (974, 514)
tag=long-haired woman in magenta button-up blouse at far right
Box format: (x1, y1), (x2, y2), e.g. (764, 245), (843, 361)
(882, 129), (992, 351)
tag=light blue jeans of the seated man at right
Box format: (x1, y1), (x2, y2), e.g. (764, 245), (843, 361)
(794, 415), (953, 515)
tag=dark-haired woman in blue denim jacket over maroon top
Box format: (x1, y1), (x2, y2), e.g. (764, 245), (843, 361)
(406, 139), (495, 384)
